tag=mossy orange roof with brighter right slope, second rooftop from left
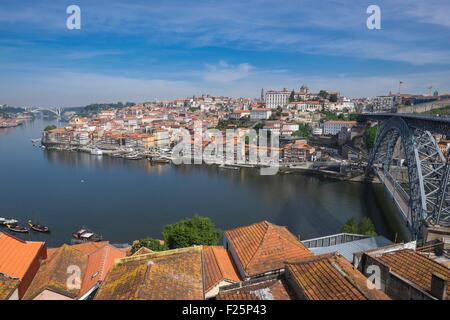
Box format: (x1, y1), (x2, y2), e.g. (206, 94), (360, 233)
(24, 241), (125, 299)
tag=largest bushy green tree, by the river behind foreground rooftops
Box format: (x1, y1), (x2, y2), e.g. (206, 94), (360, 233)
(163, 215), (221, 249)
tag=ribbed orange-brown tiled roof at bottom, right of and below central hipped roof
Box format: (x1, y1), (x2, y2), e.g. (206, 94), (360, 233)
(286, 253), (389, 300)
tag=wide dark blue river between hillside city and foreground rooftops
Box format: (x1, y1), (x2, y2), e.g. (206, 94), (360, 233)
(0, 120), (400, 246)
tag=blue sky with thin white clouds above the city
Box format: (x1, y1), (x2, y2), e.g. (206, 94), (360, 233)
(0, 0), (450, 106)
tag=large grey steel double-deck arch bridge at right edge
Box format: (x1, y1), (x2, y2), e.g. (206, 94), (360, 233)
(359, 113), (450, 239)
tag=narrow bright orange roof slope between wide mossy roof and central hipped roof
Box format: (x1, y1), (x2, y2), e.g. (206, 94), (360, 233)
(203, 246), (240, 292)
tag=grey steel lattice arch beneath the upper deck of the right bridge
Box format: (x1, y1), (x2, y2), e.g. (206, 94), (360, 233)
(369, 117), (450, 239)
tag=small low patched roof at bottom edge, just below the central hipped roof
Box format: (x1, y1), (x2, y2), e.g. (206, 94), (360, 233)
(216, 277), (294, 300)
